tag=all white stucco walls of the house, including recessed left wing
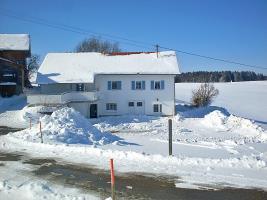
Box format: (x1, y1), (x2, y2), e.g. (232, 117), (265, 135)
(35, 75), (178, 117)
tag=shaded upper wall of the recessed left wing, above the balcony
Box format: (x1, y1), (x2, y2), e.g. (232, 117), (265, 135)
(40, 83), (95, 94)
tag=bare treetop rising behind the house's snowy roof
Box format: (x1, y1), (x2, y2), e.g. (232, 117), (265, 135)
(75, 37), (121, 53)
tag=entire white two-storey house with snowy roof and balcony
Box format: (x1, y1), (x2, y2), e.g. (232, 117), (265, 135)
(27, 51), (180, 118)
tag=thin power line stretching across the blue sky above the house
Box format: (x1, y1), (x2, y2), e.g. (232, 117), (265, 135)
(0, 8), (267, 70)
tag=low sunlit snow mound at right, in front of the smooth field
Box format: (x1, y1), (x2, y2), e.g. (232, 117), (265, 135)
(202, 110), (267, 141)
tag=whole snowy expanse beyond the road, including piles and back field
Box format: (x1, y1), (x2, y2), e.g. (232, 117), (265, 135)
(0, 82), (267, 196)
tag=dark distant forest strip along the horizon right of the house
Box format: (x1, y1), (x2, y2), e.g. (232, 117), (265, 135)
(175, 71), (267, 83)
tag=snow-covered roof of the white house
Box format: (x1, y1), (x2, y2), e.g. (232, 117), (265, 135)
(37, 51), (180, 84)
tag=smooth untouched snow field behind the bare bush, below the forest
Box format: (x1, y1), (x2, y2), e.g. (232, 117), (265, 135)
(175, 81), (267, 129)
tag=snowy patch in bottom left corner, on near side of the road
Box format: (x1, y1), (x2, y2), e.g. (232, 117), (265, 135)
(0, 154), (100, 200)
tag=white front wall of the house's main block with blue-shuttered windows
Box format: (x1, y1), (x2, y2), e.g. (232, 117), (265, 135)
(95, 75), (175, 116)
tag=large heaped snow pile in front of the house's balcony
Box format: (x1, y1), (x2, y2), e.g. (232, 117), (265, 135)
(10, 107), (120, 145)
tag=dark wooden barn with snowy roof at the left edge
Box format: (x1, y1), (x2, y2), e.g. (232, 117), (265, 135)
(0, 34), (31, 97)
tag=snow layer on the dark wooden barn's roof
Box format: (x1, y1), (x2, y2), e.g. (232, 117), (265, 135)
(0, 34), (30, 51)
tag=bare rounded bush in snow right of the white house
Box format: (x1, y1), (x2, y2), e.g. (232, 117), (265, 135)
(191, 83), (219, 107)
